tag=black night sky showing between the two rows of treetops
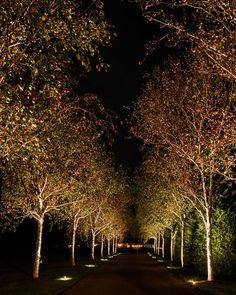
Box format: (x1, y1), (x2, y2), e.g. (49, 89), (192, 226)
(79, 0), (160, 169)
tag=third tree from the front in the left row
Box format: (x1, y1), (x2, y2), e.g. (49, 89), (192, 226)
(79, 158), (130, 260)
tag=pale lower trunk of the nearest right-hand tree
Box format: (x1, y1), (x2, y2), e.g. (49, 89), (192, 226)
(205, 210), (214, 281)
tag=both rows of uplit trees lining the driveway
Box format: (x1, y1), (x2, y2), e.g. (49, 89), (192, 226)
(0, 0), (236, 280)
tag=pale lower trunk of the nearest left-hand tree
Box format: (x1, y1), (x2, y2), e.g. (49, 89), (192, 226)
(33, 218), (44, 279)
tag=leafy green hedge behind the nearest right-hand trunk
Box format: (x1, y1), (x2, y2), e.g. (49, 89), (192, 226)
(175, 208), (236, 276)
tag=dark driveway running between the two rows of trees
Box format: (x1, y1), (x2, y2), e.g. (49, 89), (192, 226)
(62, 253), (200, 295)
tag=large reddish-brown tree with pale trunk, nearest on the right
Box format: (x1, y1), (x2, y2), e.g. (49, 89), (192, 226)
(132, 57), (236, 281)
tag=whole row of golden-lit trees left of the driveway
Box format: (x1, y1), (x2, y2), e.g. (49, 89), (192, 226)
(0, 0), (128, 278)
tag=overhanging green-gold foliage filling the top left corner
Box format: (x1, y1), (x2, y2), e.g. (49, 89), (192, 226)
(0, 0), (110, 88)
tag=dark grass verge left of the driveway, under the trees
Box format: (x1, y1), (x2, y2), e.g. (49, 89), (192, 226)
(0, 252), (106, 295)
